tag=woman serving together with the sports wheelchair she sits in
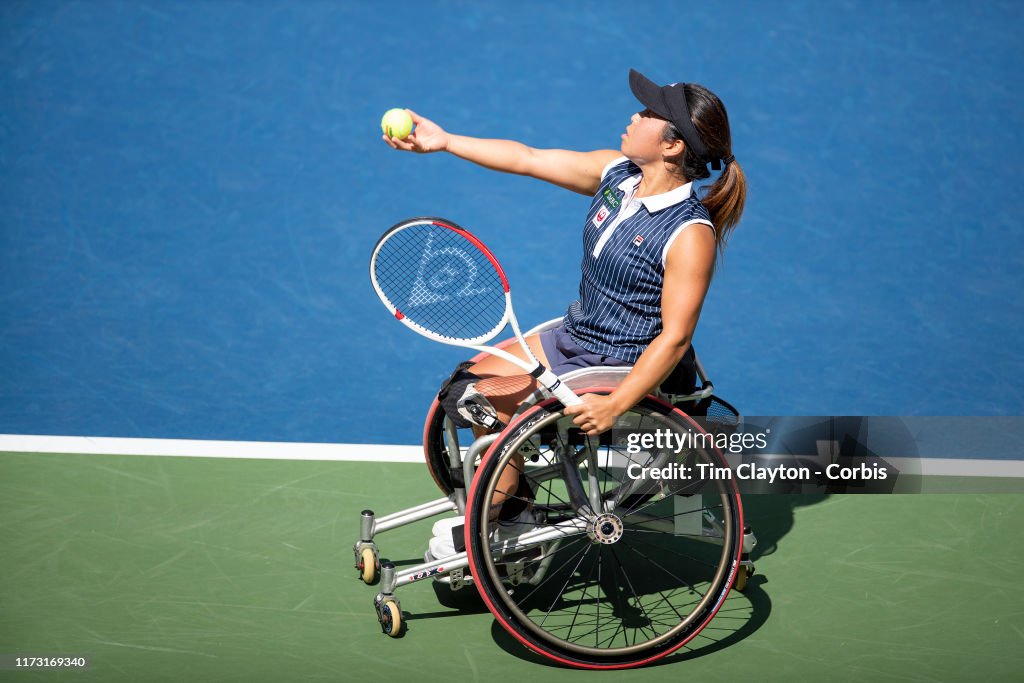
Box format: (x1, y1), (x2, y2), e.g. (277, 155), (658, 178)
(368, 71), (755, 669)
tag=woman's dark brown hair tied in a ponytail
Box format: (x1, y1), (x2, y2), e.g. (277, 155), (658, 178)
(662, 83), (746, 254)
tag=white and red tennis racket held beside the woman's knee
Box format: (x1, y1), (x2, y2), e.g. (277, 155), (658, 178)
(370, 217), (583, 405)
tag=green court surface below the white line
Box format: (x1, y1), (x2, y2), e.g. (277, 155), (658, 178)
(0, 454), (1024, 681)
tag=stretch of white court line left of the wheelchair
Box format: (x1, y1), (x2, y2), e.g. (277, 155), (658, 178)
(0, 434), (423, 463)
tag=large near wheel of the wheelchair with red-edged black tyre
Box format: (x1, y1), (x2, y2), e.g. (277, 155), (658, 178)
(466, 396), (743, 669)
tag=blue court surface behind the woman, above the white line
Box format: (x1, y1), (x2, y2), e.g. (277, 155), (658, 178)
(0, 0), (1024, 443)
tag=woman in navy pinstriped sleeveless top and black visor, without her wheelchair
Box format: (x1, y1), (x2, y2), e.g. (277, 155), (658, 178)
(384, 70), (745, 435)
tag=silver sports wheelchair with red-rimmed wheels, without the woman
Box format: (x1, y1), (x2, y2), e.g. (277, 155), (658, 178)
(353, 318), (757, 669)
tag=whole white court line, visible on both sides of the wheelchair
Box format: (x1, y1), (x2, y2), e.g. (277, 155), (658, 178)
(0, 434), (1024, 478)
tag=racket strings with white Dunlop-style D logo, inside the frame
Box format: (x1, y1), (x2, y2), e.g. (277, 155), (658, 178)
(374, 223), (506, 340)
